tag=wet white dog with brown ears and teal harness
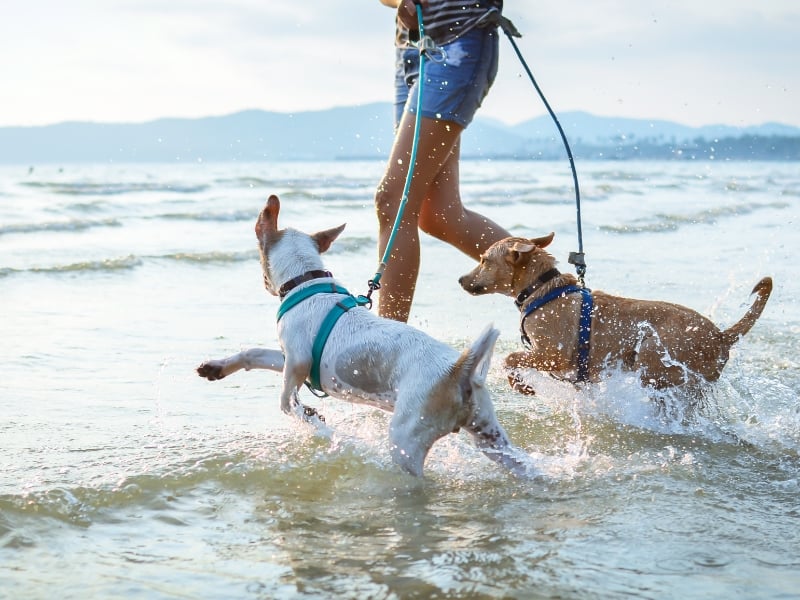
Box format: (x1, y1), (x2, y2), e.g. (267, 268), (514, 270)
(197, 196), (529, 475)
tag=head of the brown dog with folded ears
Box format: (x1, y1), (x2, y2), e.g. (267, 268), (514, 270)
(458, 233), (556, 297)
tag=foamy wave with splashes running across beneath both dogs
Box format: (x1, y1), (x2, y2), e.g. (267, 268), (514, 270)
(0, 374), (800, 544)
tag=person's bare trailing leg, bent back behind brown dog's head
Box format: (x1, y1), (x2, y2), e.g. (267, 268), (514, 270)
(419, 136), (510, 260)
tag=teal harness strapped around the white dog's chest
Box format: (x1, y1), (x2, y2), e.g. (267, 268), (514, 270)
(277, 271), (369, 392)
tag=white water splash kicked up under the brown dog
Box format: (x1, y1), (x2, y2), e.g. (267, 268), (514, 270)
(510, 364), (800, 458)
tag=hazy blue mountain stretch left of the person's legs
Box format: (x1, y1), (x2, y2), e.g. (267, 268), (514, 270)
(0, 104), (392, 163)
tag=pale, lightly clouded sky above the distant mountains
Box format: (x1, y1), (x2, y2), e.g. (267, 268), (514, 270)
(0, 0), (800, 126)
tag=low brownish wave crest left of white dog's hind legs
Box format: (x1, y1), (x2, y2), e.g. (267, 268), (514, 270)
(0, 434), (384, 528)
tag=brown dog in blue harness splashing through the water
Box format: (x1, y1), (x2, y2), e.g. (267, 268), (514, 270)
(459, 233), (772, 393)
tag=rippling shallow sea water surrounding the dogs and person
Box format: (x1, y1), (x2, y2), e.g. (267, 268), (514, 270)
(0, 160), (800, 599)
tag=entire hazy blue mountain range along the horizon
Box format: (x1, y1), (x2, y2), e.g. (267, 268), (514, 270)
(0, 103), (800, 164)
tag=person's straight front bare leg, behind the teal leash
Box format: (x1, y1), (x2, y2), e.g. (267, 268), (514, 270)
(375, 113), (463, 321)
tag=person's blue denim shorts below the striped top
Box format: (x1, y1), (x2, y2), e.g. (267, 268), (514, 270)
(394, 27), (499, 127)
